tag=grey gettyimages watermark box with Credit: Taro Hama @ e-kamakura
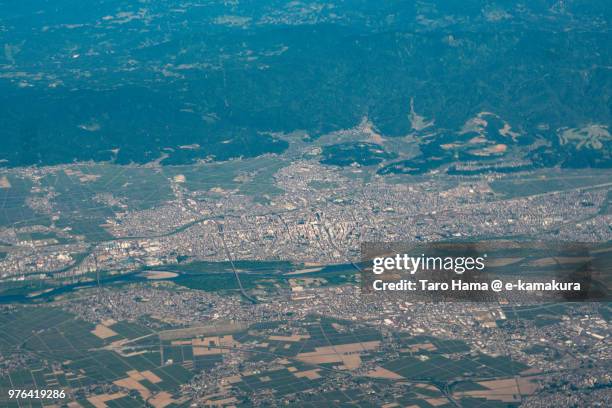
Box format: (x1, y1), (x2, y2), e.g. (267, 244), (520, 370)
(361, 240), (612, 302)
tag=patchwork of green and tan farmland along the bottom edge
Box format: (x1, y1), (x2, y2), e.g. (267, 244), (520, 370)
(0, 306), (556, 407)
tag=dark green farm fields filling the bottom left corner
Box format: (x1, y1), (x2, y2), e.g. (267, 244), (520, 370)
(0, 306), (194, 407)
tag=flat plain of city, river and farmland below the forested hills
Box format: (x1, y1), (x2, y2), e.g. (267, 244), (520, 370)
(0, 156), (612, 407)
